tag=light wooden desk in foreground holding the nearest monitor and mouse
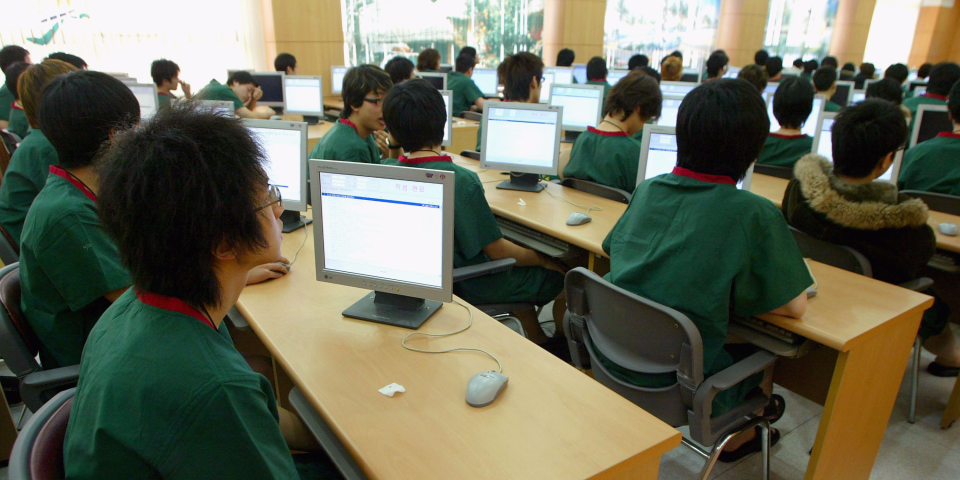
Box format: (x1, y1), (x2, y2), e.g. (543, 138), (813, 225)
(237, 229), (680, 480)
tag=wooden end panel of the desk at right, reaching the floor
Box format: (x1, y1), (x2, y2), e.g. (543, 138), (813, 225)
(806, 312), (921, 480)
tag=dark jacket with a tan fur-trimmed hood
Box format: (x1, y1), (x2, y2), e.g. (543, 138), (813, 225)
(781, 154), (937, 283)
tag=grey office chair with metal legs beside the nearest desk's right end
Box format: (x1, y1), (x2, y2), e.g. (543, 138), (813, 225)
(563, 267), (777, 480)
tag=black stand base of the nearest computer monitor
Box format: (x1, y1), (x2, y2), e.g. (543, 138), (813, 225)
(343, 292), (443, 330)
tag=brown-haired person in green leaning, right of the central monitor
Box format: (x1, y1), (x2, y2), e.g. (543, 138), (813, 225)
(563, 72), (663, 192)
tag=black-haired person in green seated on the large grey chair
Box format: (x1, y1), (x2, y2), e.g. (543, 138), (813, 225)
(598, 79), (813, 461)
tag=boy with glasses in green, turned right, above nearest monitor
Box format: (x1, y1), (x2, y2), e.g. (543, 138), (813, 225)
(310, 65), (400, 163)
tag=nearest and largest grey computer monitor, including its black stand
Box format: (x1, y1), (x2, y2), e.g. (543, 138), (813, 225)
(310, 160), (455, 329)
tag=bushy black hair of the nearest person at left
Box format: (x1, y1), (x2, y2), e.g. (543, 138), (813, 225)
(97, 104), (271, 307)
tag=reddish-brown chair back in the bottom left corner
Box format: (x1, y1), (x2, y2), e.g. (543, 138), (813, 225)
(7, 388), (77, 480)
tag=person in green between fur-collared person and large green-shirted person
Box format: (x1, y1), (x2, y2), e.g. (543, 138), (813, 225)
(757, 77), (815, 167)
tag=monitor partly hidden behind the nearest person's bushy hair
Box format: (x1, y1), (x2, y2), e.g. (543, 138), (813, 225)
(243, 118), (310, 233)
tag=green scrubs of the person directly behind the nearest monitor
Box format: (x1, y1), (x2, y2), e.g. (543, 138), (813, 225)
(384, 156), (563, 305)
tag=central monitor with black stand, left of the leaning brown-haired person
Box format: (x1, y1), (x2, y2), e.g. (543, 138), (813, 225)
(480, 102), (563, 192)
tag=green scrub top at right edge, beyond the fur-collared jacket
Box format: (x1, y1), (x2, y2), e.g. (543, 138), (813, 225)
(897, 132), (960, 196)
